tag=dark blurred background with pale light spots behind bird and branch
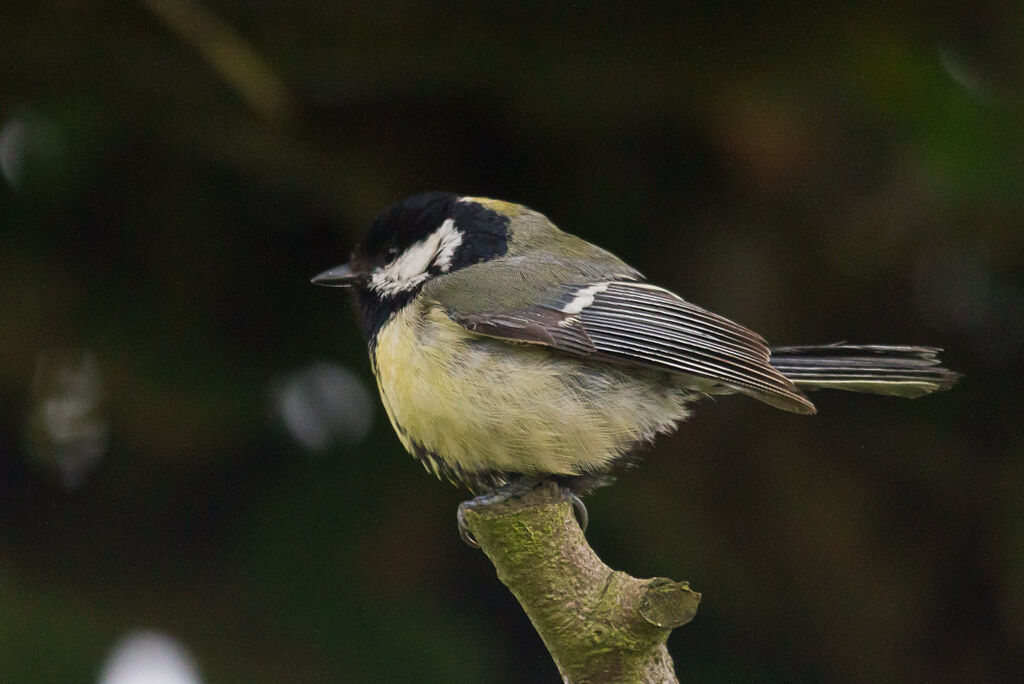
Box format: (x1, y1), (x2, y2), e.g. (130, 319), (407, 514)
(0, 0), (1024, 684)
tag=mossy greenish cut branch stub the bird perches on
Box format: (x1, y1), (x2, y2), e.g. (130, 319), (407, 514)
(460, 482), (700, 684)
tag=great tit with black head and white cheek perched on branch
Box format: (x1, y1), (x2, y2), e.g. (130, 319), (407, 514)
(312, 193), (957, 493)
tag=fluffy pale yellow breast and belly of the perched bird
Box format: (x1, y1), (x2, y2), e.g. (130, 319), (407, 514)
(374, 301), (690, 479)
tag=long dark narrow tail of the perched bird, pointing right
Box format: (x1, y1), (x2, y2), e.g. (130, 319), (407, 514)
(771, 344), (961, 398)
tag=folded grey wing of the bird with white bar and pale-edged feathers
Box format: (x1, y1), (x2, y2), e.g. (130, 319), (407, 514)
(440, 270), (814, 414)
